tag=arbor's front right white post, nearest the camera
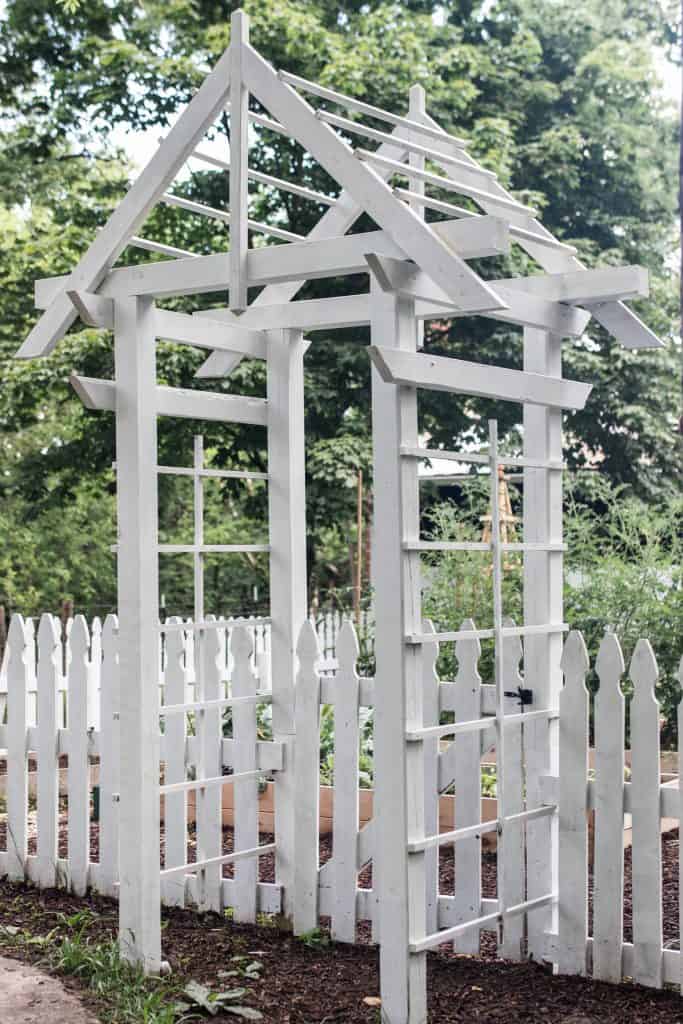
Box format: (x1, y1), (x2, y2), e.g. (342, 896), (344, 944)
(372, 282), (427, 1024)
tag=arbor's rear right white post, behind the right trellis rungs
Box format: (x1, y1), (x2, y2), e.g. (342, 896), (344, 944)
(523, 328), (562, 961)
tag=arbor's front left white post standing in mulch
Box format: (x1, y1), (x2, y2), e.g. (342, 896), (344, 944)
(115, 298), (161, 973)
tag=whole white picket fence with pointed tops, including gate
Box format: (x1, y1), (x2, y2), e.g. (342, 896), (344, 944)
(0, 614), (683, 987)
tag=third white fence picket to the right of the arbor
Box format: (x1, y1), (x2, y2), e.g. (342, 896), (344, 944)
(629, 640), (663, 988)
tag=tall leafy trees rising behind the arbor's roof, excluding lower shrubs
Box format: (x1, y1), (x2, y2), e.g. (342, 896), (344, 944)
(0, 0), (680, 606)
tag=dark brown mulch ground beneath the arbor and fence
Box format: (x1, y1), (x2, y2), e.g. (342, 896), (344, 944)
(0, 830), (683, 1024)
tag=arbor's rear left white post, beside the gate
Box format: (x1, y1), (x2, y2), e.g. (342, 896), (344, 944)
(267, 331), (307, 916)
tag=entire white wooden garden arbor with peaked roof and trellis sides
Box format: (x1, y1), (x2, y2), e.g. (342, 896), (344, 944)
(17, 11), (659, 1024)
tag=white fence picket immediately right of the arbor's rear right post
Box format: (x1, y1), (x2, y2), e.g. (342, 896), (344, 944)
(558, 630), (590, 975)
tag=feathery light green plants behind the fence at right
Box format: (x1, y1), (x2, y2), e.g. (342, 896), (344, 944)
(424, 473), (683, 742)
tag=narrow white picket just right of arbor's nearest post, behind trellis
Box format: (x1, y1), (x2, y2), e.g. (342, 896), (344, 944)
(421, 620), (439, 933)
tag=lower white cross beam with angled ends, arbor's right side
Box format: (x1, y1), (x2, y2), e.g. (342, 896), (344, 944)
(370, 345), (591, 409)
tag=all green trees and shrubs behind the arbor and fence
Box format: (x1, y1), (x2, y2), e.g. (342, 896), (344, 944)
(0, 0), (683, 696)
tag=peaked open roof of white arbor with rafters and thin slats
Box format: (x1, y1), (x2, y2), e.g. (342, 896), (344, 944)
(16, 11), (660, 364)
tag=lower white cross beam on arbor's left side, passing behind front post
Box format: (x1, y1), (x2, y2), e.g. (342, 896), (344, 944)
(70, 374), (267, 427)
